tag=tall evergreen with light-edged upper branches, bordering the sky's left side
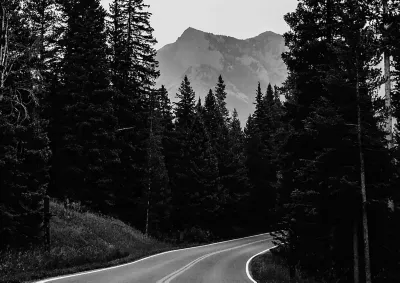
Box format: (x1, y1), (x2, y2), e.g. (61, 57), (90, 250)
(107, 0), (162, 230)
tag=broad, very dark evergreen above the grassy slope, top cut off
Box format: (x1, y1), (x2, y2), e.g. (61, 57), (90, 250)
(53, 0), (119, 212)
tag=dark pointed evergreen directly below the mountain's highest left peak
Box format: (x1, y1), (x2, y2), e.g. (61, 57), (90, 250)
(172, 76), (223, 240)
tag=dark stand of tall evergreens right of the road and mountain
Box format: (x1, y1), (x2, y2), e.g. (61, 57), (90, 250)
(275, 0), (400, 282)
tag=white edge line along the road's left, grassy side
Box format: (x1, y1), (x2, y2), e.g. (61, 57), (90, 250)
(34, 232), (271, 283)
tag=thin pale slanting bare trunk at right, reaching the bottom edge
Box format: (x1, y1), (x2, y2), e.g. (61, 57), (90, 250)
(356, 58), (371, 283)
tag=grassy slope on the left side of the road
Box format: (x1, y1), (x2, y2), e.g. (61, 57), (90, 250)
(0, 202), (175, 283)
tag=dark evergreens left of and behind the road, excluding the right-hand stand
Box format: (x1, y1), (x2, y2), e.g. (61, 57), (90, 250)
(0, 0), (281, 248)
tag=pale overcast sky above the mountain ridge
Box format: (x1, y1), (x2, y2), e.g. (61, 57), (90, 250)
(101, 0), (297, 49)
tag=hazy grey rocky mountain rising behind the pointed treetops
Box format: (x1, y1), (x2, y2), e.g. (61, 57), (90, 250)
(156, 27), (287, 126)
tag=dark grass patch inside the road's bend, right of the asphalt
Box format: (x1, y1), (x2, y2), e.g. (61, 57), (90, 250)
(250, 252), (317, 283)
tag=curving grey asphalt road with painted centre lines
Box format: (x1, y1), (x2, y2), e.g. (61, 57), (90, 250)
(38, 234), (273, 283)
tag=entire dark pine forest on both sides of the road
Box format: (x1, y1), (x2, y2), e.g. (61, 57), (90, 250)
(0, 0), (400, 283)
